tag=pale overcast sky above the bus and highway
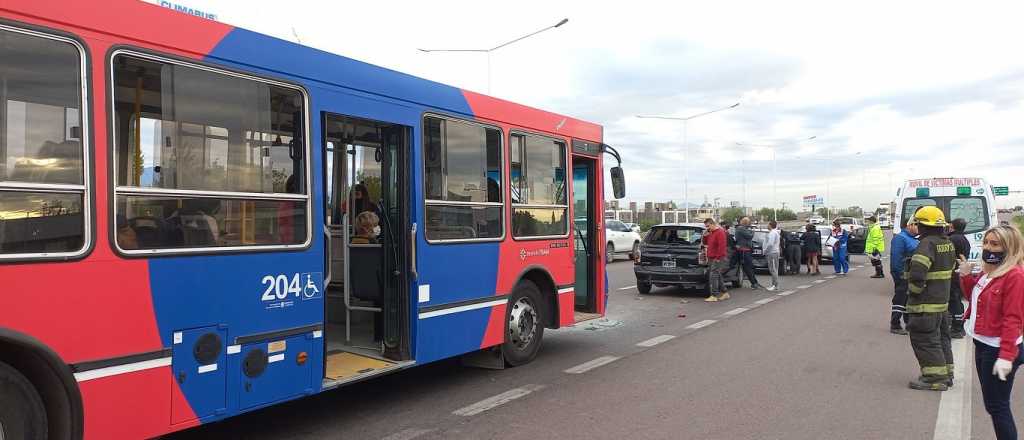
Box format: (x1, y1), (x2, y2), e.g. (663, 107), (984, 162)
(159, 0), (1024, 207)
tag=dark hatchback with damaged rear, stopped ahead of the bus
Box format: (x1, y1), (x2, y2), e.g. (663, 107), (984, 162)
(633, 223), (740, 294)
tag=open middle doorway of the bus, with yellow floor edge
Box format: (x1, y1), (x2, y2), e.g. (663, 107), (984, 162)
(324, 114), (412, 385)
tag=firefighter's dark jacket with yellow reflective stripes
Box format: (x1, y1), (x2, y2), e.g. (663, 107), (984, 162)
(906, 235), (956, 313)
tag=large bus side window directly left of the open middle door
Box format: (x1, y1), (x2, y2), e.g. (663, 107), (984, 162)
(113, 53), (309, 251)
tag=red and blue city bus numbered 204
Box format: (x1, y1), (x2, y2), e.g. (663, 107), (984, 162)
(0, 0), (623, 439)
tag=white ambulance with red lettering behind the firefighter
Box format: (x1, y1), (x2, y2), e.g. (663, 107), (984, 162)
(893, 177), (998, 261)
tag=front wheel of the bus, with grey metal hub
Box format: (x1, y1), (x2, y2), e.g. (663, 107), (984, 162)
(502, 279), (545, 366)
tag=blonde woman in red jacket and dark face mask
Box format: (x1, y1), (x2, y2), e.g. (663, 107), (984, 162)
(959, 226), (1024, 440)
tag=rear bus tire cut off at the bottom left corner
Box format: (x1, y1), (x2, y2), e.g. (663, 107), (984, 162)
(0, 362), (47, 440)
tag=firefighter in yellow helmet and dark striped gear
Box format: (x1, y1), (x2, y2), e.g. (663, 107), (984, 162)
(904, 207), (956, 391)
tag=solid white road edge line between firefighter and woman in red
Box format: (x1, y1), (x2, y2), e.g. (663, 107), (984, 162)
(933, 338), (974, 440)
